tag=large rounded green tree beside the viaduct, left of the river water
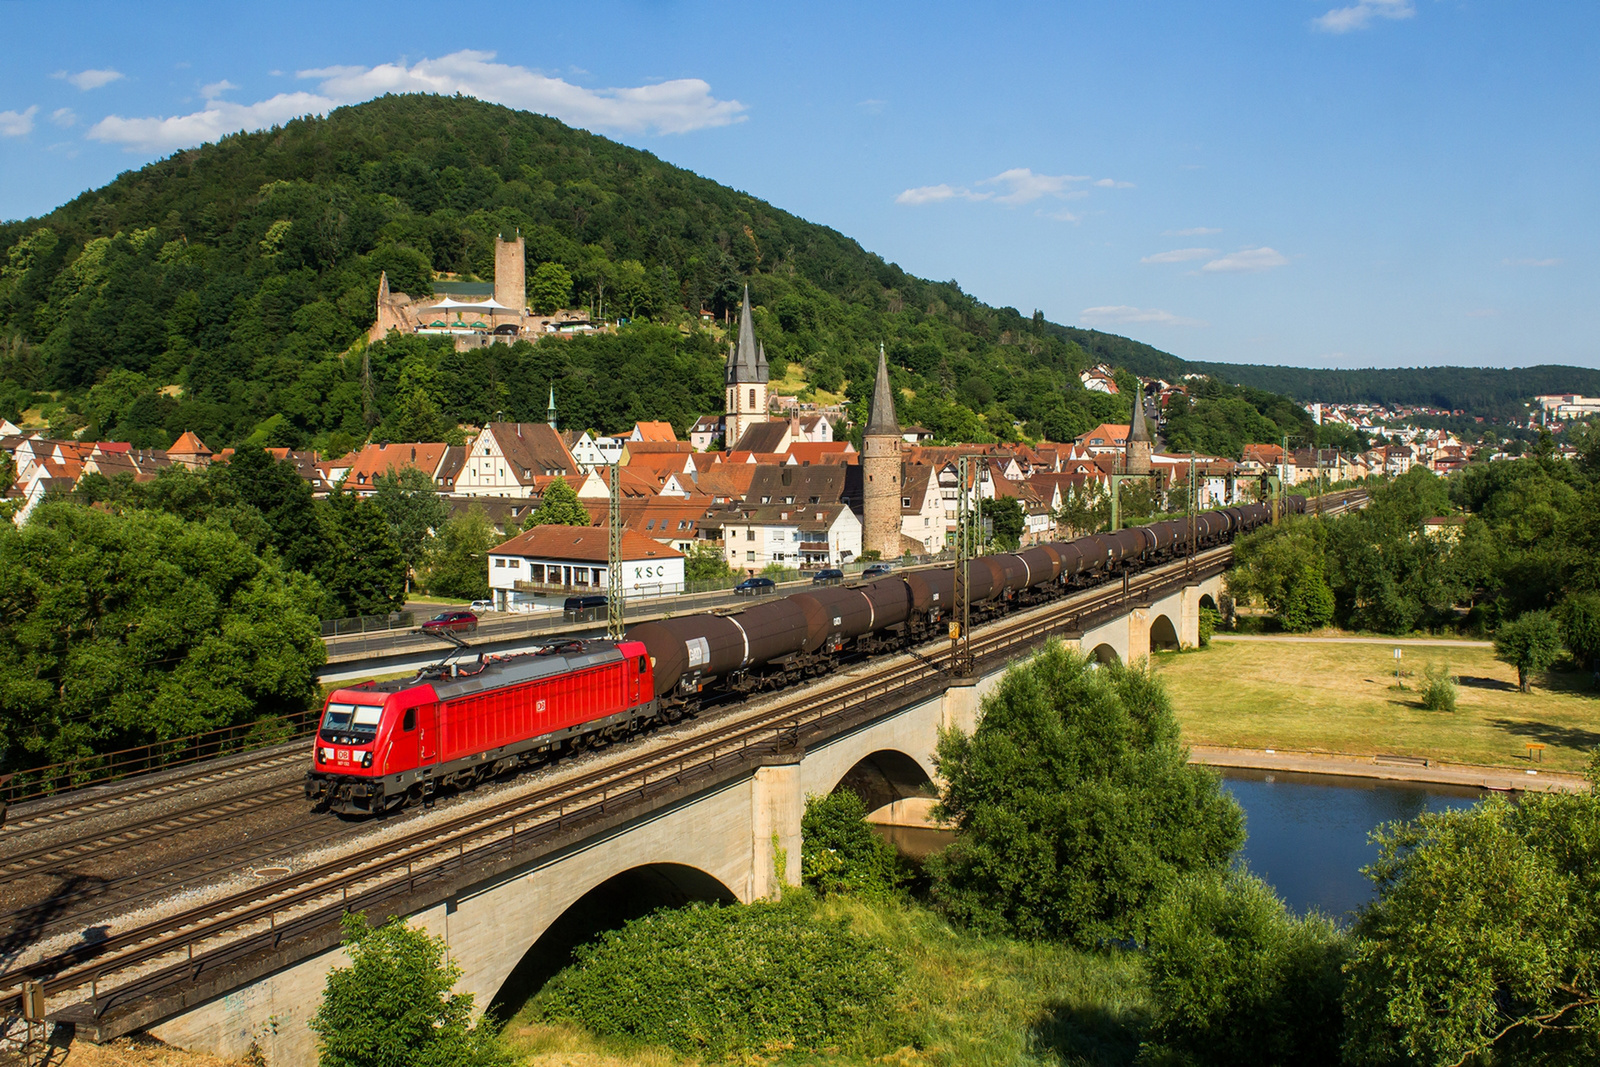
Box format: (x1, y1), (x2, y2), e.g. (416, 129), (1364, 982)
(930, 643), (1243, 945)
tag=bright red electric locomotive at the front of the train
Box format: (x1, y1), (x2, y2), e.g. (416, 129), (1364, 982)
(306, 641), (661, 814)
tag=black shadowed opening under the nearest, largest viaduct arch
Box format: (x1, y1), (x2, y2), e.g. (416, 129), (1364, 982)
(480, 862), (736, 1019)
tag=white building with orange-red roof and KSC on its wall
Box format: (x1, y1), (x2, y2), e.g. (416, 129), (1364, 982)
(490, 526), (683, 611)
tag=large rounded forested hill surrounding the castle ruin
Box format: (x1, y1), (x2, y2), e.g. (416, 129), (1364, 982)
(0, 96), (1152, 451)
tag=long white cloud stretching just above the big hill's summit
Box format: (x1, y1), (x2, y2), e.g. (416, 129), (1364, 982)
(88, 51), (746, 150)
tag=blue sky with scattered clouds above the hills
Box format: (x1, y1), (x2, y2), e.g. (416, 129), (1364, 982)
(0, 0), (1600, 366)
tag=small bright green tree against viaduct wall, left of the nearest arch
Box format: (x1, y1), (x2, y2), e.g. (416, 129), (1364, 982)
(310, 915), (512, 1067)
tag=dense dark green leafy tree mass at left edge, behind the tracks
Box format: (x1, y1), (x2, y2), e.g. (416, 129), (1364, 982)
(0, 501), (325, 768)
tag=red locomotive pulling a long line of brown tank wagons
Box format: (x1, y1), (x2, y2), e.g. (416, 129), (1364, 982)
(306, 494), (1349, 814)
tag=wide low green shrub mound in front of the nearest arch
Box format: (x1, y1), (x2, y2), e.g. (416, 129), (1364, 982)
(536, 894), (902, 1059)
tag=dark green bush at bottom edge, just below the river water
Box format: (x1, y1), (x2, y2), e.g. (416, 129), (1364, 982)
(1146, 870), (1347, 1067)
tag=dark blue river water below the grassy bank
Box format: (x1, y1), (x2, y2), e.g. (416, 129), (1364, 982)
(1222, 769), (1485, 918)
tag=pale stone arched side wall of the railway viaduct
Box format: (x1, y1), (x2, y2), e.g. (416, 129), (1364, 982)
(144, 576), (1221, 1065)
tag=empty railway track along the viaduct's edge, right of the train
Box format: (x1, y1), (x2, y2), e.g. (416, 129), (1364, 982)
(0, 549), (1230, 1016)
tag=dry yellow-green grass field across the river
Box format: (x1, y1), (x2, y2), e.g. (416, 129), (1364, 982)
(1152, 641), (1600, 773)
